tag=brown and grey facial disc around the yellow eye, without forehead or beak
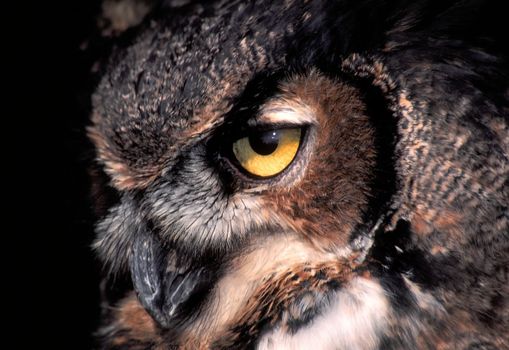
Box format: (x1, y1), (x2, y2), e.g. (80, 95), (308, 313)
(91, 66), (376, 274)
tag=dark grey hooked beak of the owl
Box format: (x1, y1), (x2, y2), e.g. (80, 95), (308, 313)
(129, 230), (211, 328)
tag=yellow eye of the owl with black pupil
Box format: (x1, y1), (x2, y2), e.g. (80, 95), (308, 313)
(233, 128), (302, 177)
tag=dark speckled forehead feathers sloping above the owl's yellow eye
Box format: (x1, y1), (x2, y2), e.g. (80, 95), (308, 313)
(89, 3), (342, 189)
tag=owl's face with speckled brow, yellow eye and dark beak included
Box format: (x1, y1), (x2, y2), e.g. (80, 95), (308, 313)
(89, 6), (384, 334)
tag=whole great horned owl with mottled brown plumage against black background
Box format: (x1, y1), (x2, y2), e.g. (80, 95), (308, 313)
(89, 0), (509, 349)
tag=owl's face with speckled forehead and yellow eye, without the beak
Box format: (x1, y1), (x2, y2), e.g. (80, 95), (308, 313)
(89, 3), (384, 270)
